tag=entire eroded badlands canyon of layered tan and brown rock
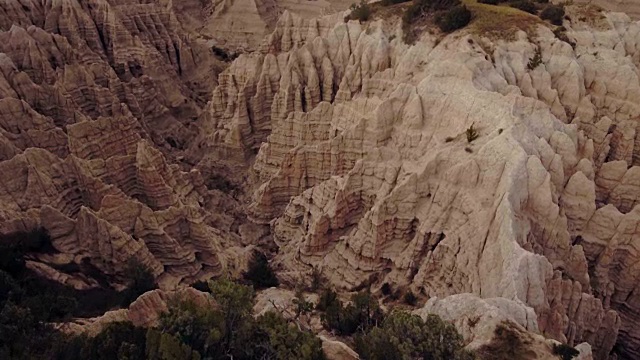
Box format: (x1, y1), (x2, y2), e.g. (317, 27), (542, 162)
(0, 0), (640, 359)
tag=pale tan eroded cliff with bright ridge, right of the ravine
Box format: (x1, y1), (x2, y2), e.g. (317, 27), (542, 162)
(191, 7), (640, 358)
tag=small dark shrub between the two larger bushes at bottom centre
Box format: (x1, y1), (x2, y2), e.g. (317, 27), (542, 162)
(316, 290), (383, 335)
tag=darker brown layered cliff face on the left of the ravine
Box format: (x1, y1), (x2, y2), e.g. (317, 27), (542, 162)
(0, 0), (255, 288)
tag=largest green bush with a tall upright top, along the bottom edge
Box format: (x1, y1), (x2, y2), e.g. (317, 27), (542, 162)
(154, 279), (324, 360)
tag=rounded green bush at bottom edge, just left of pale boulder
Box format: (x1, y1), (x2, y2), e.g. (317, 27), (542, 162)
(355, 311), (474, 360)
